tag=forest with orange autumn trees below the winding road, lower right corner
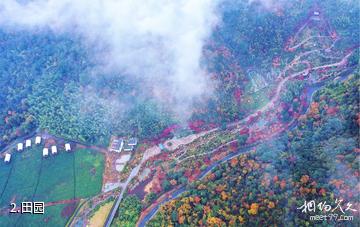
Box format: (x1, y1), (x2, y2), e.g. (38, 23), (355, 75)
(148, 72), (360, 226)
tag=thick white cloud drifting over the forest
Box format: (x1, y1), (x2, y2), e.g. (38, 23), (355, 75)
(0, 0), (218, 119)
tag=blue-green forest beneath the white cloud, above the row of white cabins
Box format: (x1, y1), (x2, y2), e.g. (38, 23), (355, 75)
(0, 30), (172, 148)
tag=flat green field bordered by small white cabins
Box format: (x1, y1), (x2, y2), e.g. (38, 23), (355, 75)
(0, 148), (104, 226)
